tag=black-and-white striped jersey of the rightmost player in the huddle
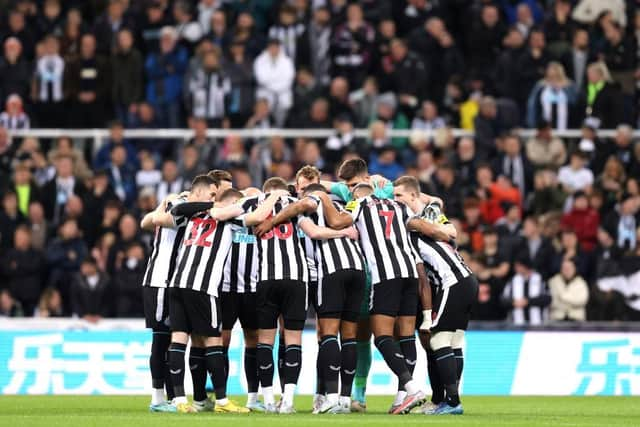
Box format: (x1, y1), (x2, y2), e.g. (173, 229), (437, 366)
(411, 232), (473, 289)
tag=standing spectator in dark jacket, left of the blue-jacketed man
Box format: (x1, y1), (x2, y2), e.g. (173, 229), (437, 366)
(111, 29), (143, 124)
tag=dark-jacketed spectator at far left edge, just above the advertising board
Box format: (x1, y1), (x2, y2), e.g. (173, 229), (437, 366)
(2, 224), (46, 316)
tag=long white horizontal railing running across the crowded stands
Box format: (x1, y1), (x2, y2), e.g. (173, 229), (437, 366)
(5, 129), (624, 155)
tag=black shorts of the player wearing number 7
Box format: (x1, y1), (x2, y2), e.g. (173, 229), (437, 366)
(369, 278), (419, 317)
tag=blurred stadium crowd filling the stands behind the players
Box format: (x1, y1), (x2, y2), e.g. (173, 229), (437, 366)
(0, 0), (640, 324)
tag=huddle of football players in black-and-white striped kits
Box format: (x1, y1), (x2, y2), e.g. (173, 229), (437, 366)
(142, 159), (478, 415)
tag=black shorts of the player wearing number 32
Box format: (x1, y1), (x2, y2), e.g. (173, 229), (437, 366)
(169, 288), (222, 337)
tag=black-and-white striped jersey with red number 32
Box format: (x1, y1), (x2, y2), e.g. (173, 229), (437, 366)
(170, 212), (238, 296)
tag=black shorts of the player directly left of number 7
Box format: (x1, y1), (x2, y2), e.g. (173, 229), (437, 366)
(312, 269), (366, 322)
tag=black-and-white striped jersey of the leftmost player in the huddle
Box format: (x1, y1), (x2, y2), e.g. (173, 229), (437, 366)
(142, 199), (189, 288)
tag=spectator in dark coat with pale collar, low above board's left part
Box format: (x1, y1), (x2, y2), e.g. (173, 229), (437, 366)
(71, 257), (112, 323)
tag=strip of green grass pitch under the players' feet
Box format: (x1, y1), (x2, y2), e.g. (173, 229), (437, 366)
(0, 396), (640, 427)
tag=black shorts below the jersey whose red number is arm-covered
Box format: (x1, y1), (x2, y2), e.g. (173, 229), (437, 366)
(257, 280), (307, 331)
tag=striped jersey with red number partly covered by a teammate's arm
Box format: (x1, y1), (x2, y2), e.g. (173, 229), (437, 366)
(242, 193), (309, 283)
